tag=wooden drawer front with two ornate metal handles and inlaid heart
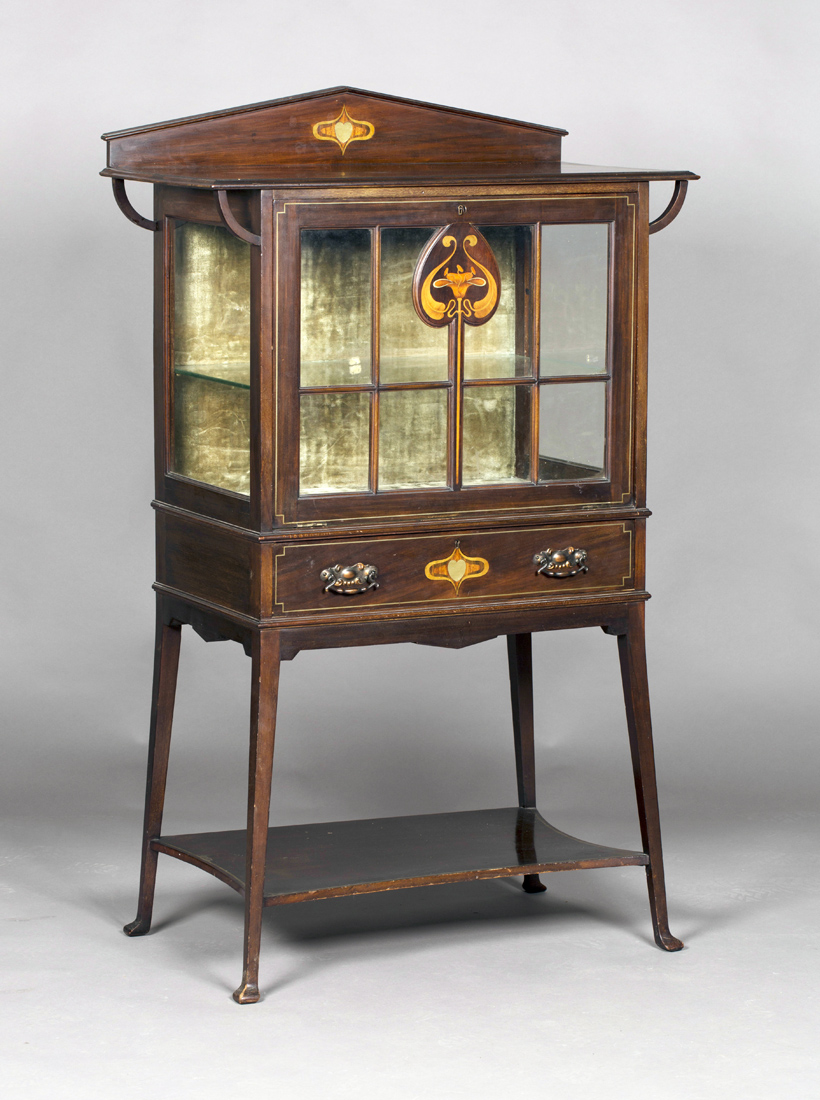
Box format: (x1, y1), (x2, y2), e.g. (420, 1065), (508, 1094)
(273, 523), (635, 614)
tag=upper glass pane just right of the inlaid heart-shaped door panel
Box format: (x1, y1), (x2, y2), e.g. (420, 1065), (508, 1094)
(464, 226), (533, 378)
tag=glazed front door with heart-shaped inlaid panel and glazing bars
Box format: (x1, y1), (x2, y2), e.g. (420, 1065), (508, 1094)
(275, 194), (636, 523)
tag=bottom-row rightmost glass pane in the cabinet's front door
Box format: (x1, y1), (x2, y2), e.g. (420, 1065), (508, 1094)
(538, 382), (606, 481)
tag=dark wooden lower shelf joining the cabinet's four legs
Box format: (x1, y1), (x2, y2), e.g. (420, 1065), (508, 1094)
(156, 806), (649, 905)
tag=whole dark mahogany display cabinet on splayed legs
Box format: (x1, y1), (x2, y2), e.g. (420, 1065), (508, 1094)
(103, 88), (698, 1003)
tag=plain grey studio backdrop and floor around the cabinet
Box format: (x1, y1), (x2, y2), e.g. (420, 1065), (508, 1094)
(0, 0), (820, 1100)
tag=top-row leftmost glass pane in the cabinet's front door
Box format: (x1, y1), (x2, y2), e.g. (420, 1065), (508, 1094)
(299, 229), (371, 386)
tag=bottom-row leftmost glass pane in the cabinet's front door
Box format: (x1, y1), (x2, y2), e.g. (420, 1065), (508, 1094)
(299, 393), (370, 496)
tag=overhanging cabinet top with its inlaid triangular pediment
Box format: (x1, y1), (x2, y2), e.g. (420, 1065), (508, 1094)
(102, 87), (698, 189)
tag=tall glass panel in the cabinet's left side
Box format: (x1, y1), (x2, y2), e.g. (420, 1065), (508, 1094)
(172, 222), (251, 495)
